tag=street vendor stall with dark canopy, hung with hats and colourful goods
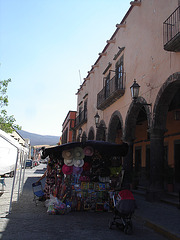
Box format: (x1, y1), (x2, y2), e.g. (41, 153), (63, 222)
(41, 141), (128, 214)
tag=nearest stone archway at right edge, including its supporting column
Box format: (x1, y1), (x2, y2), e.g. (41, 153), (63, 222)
(150, 72), (180, 193)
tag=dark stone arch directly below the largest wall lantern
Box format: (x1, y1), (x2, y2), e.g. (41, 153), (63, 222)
(123, 97), (152, 142)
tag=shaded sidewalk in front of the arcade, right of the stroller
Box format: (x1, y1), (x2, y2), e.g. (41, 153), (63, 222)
(134, 194), (180, 240)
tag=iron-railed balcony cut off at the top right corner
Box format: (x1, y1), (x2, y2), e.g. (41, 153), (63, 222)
(163, 6), (180, 52)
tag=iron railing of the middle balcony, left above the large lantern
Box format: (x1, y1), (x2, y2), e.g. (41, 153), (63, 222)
(97, 72), (125, 110)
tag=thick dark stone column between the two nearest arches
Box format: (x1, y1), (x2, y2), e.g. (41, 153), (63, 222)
(146, 129), (165, 201)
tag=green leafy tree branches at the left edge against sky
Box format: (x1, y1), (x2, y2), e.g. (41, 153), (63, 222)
(0, 78), (21, 133)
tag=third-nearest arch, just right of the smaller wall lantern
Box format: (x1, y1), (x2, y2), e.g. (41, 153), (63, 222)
(108, 111), (123, 142)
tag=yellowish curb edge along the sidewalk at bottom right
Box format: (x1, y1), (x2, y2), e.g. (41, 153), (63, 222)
(135, 215), (180, 240)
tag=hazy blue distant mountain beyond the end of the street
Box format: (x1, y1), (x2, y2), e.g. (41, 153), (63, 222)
(16, 130), (60, 146)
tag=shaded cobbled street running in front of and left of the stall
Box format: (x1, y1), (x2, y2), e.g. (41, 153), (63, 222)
(0, 164), (170, 240)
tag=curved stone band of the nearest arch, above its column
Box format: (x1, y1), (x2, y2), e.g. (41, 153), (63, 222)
(152, 72), (180, 131)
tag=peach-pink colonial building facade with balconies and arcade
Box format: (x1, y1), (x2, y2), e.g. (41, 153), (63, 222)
(64, 0), (180, 196)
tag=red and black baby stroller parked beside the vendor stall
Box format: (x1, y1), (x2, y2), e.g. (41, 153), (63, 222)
(109, 189), (136, 234)
